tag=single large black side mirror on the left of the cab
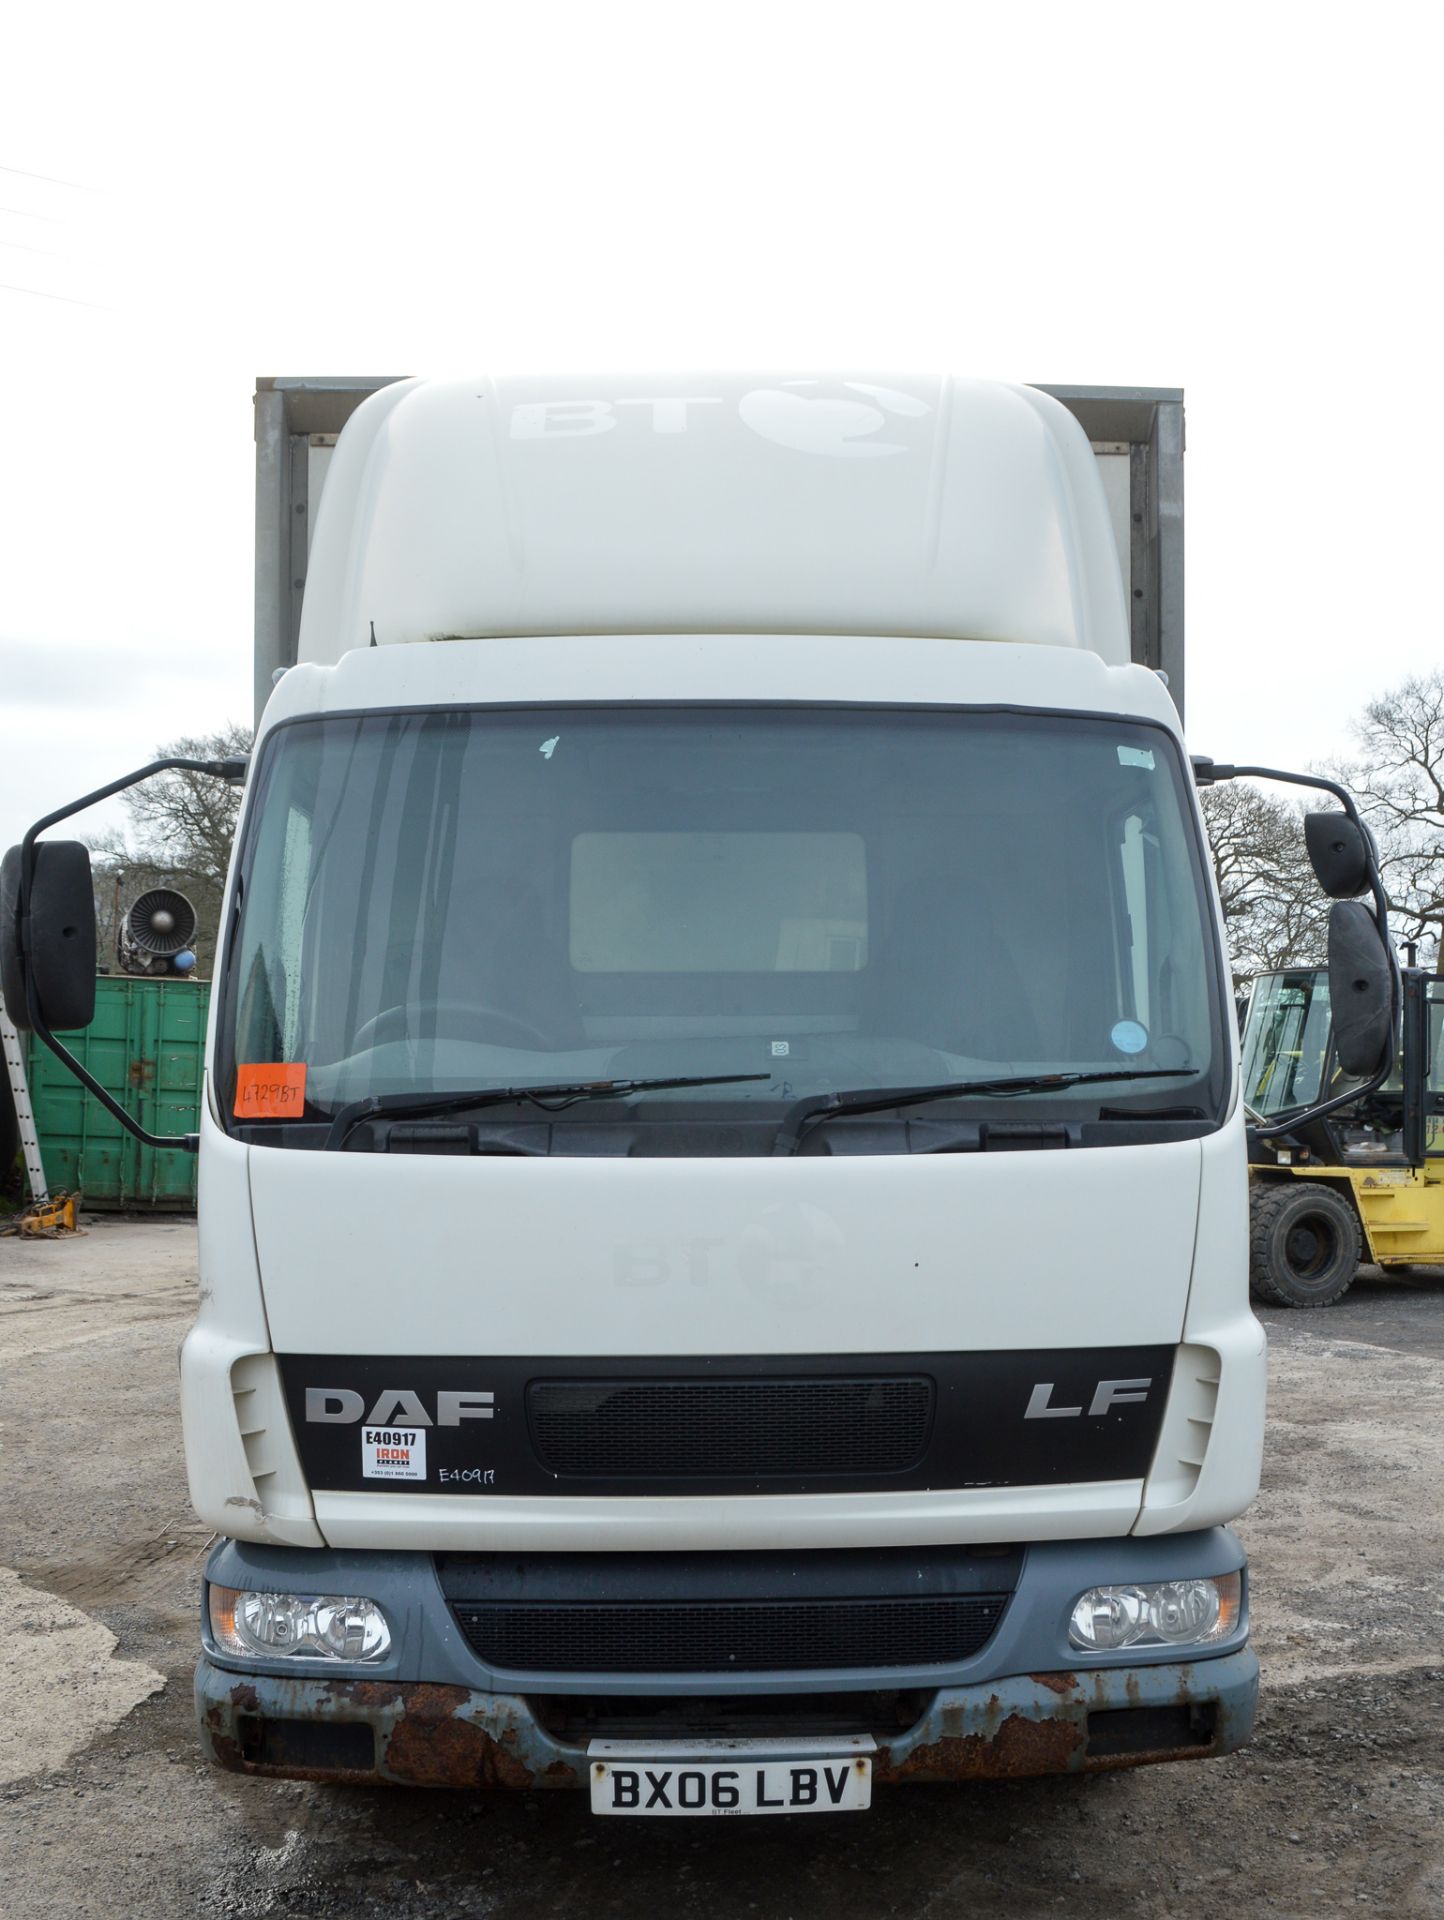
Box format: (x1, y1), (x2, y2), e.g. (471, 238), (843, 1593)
(0, 841), (96, 1029)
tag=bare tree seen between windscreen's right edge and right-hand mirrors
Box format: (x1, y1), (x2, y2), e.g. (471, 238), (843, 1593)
(1200, 780), (1329, 993)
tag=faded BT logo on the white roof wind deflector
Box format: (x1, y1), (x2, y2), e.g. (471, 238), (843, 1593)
(511, 380), (933, 461)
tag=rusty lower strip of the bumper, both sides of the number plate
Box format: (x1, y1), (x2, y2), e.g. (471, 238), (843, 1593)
(196, 1649), (1258, 1788)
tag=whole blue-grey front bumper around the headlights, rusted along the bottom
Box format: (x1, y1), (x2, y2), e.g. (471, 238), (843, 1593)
(196, 1528), (1258, 1788)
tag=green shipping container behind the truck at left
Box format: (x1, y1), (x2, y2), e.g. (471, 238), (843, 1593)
(25, 975), (211, 1212)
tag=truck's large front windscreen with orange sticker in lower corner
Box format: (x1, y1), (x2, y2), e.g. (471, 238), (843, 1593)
(221, 707), (1227, 1144)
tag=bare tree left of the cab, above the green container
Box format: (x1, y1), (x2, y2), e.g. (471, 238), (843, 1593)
(90, 722), (252, 975)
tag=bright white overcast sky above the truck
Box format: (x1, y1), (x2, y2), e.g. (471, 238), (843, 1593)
(0, 0), (1444, 845)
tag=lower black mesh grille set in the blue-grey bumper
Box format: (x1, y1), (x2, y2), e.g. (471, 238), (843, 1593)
(455, 1594), (1008, 1674)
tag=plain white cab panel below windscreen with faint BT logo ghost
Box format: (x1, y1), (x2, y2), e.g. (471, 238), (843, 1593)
(252, 1140), (1198, 1357)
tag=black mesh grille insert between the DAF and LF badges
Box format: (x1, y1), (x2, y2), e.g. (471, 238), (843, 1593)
(526, 1377), (933, 1480)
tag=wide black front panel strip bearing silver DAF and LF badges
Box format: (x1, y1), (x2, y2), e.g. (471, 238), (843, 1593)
(278, 1351), (1177, 1497)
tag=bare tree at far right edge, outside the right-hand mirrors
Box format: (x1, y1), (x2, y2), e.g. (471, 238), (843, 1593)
(1338, 668), (1444, 970)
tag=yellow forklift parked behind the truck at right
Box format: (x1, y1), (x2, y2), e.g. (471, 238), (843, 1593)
(1242, 948), (1444, 1308)
